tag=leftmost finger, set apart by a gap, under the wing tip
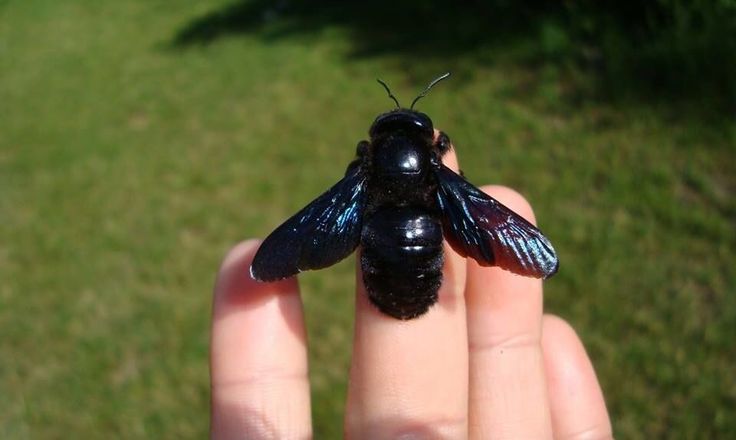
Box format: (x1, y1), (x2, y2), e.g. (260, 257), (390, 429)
(210, 240), (311, 439)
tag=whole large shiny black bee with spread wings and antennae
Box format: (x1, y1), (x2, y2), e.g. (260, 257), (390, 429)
(250, 72), (559, 319)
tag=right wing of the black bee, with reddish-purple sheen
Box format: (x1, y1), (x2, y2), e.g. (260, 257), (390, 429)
(437, 165), (559, 278)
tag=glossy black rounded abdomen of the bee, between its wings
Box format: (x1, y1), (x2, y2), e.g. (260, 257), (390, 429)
(361, 207), (443, 319)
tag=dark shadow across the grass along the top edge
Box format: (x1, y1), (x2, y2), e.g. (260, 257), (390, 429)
(172, 0), (736, 118)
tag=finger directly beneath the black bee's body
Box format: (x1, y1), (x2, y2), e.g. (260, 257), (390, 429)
(345, 153), (468, 439)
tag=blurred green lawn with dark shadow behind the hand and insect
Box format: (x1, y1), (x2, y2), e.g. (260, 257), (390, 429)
(0, 0), (736, 439)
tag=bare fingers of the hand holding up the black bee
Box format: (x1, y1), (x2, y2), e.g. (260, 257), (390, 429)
(210, 140), (613, 440)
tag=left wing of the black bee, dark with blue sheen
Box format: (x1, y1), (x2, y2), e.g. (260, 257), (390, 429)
(250, 166), (365, 281)
